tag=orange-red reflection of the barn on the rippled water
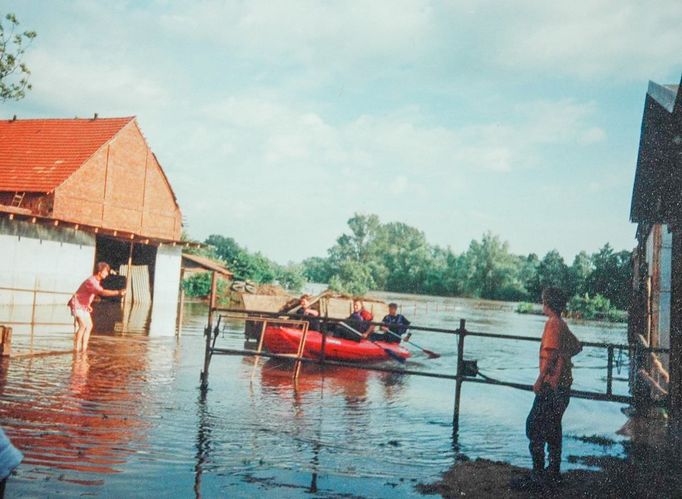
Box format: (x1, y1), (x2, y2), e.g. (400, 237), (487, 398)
(0, 338), (148, 484)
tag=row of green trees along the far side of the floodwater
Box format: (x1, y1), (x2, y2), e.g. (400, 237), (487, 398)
(182, 214), (632, 309)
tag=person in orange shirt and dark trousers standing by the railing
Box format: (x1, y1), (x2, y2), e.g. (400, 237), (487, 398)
(526, 288), (582, 485)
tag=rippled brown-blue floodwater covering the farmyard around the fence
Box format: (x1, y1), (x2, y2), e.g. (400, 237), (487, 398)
(0, 294), (627, 498)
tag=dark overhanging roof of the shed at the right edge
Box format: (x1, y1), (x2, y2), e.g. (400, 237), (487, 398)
(630, 75), (682, 223)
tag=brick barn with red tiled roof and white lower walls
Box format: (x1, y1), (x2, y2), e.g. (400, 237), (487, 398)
(0, 115), (182, 332)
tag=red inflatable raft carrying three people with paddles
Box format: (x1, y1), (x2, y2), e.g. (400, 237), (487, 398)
(263, 326), (410, 362)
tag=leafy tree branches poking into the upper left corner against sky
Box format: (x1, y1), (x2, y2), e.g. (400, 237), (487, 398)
(0, 13), (37, 102)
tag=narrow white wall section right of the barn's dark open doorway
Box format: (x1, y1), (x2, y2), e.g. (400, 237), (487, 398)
(149, 245), (182, 336)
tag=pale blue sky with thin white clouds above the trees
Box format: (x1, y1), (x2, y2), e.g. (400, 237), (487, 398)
(0, 0), (682, 263)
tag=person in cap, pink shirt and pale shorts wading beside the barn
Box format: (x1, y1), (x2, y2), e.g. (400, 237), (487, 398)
(68, 262), (125, 352)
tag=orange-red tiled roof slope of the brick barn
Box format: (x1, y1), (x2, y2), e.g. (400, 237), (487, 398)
(0, 116), (135, 192)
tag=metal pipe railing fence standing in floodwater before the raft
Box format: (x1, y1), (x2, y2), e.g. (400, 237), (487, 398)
(195, 278), (661, 435)
